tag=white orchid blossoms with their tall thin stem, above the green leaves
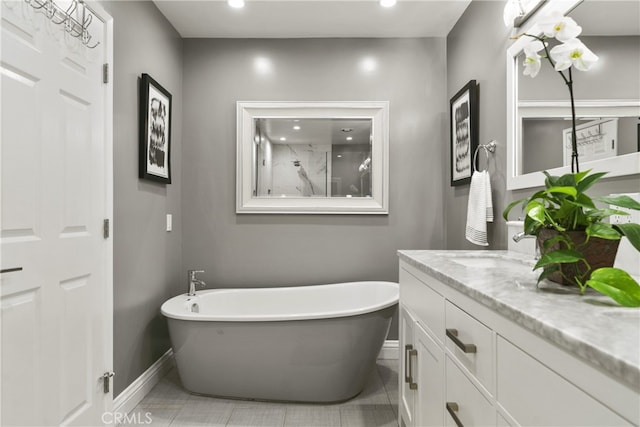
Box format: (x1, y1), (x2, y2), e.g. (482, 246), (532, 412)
(518, 12), (598, 173)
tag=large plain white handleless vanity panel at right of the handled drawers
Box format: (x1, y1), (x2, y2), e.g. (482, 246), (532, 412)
(496, 336), (630, 426)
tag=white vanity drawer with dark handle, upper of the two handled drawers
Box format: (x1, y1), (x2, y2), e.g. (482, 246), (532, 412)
(445, 301), (494, 394)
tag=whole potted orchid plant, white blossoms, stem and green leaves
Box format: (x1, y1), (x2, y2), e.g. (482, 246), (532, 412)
(503, 10), (640, 307)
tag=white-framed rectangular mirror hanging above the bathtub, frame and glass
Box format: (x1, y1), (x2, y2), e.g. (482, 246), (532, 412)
(236, 102), (389, 214)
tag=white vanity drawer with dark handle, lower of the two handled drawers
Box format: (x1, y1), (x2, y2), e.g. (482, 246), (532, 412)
(445, 355), (496, 427)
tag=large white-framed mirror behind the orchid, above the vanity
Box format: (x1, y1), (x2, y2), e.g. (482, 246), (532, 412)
(507, 0), (640, 190)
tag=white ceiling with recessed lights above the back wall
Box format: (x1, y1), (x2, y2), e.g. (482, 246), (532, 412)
(154, 0), (471, 38)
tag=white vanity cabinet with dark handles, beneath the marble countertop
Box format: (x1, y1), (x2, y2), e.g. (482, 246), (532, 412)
(398, 259), (640, 427)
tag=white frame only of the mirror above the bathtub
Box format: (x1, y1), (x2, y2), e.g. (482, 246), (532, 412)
(236, 101), (389, 215)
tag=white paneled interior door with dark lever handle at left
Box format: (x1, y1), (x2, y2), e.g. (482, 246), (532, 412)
(0, 0), (112, 425)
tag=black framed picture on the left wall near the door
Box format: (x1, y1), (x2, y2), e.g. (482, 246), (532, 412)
(139, 74), (171, 184)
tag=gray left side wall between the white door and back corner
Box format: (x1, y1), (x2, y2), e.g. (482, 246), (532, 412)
(102, 1), (184, 396)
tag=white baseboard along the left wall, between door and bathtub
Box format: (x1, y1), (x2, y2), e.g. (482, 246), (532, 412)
(113, 348), (174, 414)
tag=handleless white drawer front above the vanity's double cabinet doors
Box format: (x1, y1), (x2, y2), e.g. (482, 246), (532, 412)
(400, 268), (444, 344)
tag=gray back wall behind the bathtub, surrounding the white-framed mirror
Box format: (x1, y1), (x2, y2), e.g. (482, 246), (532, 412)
(182, 38), (447, 333)
